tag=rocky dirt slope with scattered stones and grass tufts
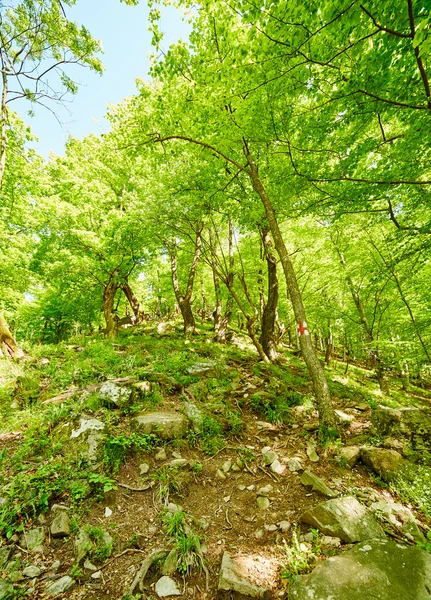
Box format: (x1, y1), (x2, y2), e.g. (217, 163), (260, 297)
(0, 330), (431, 600)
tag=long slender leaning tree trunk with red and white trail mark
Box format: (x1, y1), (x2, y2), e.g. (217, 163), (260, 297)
(244, 143), (336, 429)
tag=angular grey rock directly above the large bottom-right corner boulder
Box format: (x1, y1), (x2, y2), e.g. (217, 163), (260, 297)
(301, 496), (385, 543)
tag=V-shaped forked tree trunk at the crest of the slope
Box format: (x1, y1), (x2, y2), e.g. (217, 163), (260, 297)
(168, 223), (203, 336)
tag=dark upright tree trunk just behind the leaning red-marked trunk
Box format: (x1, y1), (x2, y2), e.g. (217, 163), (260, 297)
(260, 227), (278, 361)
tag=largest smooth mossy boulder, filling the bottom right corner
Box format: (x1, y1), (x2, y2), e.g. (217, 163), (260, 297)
(289, 540), (431, 600)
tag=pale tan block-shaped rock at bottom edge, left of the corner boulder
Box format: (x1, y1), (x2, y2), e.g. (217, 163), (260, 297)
(218, 552), (279, 598)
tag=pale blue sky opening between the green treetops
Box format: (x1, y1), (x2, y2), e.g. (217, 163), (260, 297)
(17, 0), (189, 157)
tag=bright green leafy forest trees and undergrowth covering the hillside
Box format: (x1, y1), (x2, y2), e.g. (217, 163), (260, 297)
(0, 0), (431, 600)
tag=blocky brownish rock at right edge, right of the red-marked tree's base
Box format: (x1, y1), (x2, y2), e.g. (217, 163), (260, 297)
(371, 406), (431, 451)
